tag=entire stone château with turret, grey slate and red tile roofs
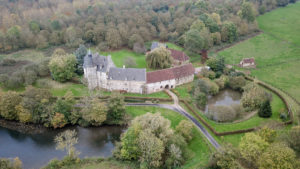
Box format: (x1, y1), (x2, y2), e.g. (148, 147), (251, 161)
(83, 51), (195, 94)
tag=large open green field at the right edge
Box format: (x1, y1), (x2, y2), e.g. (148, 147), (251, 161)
(219, 2), (300, 101)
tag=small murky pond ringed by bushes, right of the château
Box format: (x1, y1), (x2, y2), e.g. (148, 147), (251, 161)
(205, 89), (242, 112)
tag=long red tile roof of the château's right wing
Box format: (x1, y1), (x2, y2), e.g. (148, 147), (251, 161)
(147, 63), (195, 83)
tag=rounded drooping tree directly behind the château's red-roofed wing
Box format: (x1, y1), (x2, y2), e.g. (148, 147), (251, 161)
(146, 47), (173, 69)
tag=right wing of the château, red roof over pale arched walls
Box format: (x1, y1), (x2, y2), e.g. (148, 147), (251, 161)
(144, 64), (195, 93)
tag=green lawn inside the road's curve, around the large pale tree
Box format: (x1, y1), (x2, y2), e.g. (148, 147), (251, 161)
(126, 107), (211, 169)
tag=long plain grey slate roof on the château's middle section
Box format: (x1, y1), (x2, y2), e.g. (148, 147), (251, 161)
(108, 67), (146, 82)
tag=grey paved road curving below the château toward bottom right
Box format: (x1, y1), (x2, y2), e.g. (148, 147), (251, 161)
(126, 103), (220, 149)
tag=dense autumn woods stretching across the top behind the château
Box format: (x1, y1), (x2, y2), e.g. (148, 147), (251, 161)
(0, 0), (293, 52)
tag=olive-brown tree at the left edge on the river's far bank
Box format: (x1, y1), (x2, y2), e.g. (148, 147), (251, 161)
(0, 91), (22, 120)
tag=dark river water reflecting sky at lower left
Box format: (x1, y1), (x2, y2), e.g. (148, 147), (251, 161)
(0, 126), (126, 169)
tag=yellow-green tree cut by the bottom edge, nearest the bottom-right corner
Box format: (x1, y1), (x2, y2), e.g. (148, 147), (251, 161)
(258, 143), (297, 169)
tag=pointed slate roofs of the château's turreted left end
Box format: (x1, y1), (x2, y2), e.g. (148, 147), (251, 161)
(83, 53), (114, 72)
